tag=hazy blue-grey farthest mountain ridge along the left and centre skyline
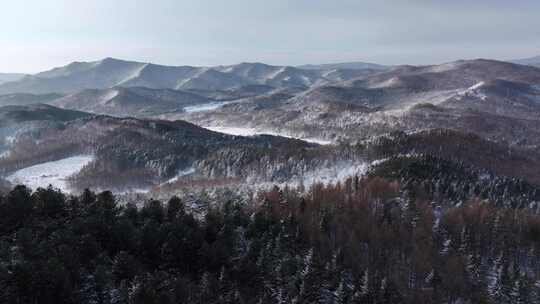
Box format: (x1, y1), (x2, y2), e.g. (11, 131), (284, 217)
(0, 58), (384, 94)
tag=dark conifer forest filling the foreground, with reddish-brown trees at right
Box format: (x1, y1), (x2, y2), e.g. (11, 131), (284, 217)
(0, 172), (540, 303)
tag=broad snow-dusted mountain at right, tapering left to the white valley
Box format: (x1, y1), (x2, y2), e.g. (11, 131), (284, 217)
(179, 59), (540, 147)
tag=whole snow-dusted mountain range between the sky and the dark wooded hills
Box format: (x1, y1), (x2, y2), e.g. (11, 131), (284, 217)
(0, 58), (540, 141)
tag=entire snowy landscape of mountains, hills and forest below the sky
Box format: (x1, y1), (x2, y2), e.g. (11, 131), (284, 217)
(0, 52), (540, 303)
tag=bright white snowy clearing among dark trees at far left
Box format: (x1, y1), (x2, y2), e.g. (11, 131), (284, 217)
(6, 155), (94, 192)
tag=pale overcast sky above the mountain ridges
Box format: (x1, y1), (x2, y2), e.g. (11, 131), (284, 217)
(0, 0), (540, 73)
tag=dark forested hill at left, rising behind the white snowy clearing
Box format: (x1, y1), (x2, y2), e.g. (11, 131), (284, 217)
(0, 105), (350, 190)
